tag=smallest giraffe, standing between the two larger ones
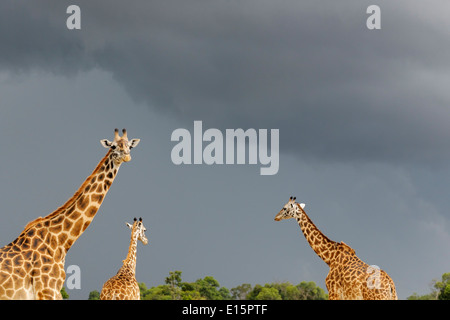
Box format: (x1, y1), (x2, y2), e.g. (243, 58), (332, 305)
(100, 218), (148, 300)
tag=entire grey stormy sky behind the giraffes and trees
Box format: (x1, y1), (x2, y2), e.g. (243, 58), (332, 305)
(0, 0), (450, 299)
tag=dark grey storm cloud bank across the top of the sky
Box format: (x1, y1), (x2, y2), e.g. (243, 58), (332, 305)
(0, 0), (450, 165)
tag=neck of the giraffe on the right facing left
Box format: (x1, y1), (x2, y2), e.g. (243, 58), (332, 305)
(297, 211), (337, 265)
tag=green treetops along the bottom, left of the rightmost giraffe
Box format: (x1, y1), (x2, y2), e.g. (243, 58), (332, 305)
(88, 271), (328, 300)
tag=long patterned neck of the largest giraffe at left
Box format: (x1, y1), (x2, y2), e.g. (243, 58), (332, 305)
(23, 150), (120, 253)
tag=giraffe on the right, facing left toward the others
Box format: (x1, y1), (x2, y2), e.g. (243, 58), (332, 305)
(275, 197), (397, 300)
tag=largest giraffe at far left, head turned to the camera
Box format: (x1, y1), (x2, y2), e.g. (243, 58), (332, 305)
(0, 129), (140, 300)
